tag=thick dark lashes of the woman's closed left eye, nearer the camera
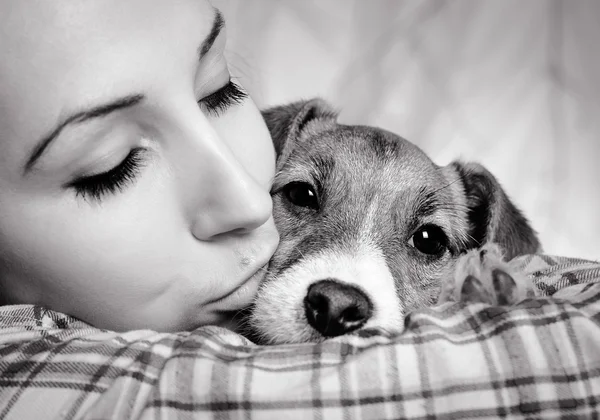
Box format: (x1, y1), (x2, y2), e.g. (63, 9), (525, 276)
(69, 147), (146, 201)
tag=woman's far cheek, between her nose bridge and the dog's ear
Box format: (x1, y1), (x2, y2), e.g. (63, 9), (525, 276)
(213, 99), (275, 189)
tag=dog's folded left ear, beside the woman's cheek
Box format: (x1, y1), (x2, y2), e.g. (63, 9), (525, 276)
(261, 98), (338, 163)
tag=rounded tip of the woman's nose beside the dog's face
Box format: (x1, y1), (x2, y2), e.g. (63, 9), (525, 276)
(192, 148), (272, 241)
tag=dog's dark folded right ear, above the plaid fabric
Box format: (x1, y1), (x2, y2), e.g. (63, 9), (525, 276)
(450, 162), (541, 260)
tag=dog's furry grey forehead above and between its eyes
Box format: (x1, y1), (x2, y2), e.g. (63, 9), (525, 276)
(276, 125), (464, 236)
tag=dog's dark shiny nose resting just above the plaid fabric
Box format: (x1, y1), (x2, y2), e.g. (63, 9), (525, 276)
(304, 279), (373, 337)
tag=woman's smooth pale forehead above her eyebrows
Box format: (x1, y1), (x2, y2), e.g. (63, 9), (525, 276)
(0, 0), (214, 172)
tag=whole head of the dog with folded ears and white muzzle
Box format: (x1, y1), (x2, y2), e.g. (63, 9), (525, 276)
(250, 99), (539, 343)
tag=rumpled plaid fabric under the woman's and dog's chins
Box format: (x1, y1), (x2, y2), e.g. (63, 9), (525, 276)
(0, 256), (600, 420)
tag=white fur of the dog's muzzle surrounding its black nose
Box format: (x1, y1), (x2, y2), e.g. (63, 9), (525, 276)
(250, 244), (403, 344)
